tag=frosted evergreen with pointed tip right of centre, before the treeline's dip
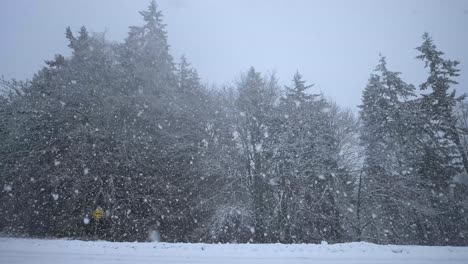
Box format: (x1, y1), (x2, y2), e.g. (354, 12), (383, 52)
(272, 73), (352, 242)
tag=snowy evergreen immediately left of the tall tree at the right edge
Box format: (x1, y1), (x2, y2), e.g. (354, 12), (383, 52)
(358, 57), (427, 243)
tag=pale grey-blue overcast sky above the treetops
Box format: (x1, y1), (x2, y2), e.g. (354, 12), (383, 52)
(0, 0), (468, 109)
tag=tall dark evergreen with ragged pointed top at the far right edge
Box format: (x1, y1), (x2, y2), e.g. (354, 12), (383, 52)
(416, 33), (468, 243)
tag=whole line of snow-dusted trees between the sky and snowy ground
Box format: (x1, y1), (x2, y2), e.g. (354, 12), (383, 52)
(0, 2), (468, 245)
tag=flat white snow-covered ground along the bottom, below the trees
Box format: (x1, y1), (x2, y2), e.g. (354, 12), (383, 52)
(0, 238), (468, 264)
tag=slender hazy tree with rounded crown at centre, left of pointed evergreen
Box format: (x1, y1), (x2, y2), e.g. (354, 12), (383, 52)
(236, 68), (278, 243)
